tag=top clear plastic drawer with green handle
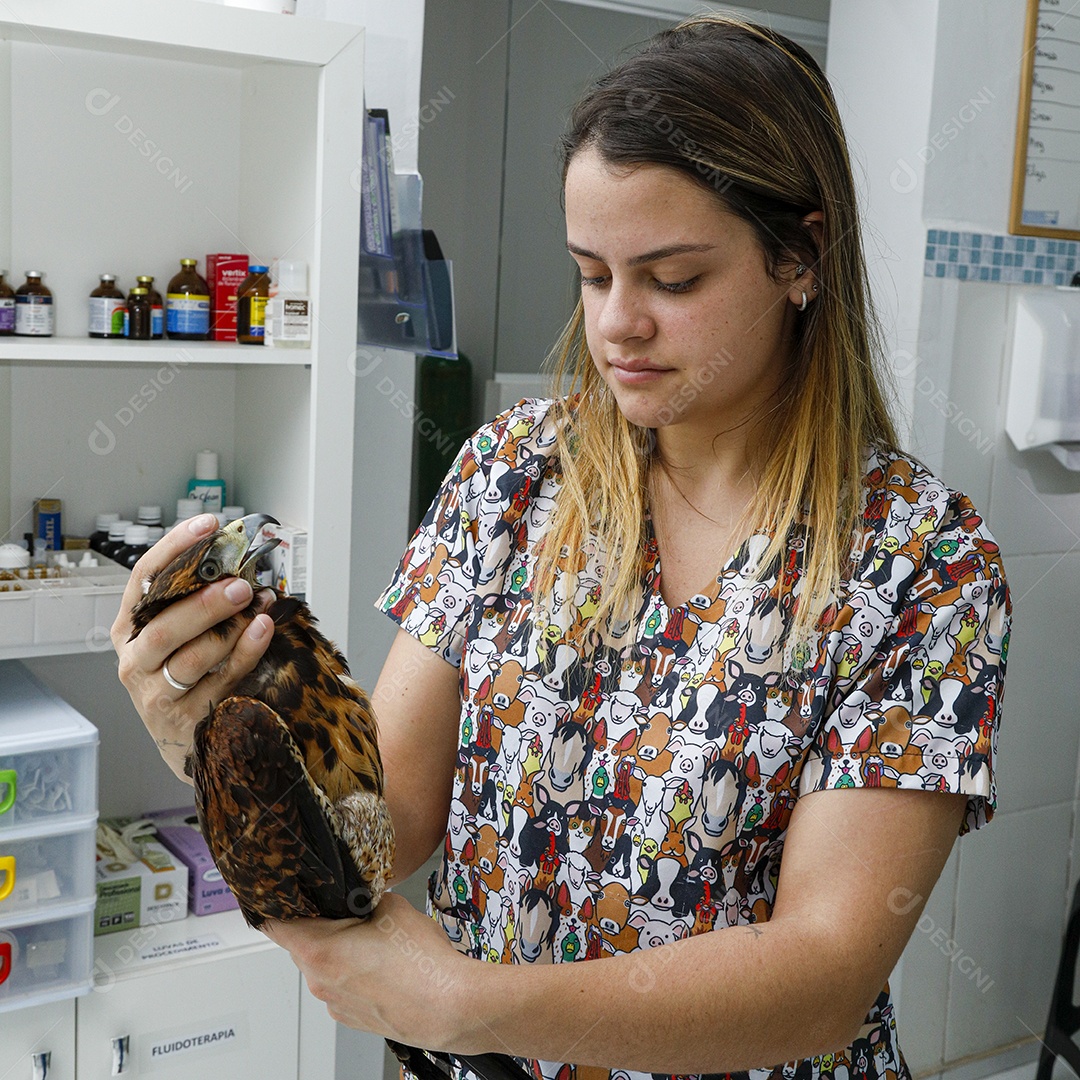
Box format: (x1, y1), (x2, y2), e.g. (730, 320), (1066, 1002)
(0, 660), (97, 829)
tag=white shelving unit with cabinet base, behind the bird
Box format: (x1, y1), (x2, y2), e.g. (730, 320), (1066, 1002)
(0, 0), (364, 1080)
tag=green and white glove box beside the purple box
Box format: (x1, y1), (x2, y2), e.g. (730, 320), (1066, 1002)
(94, 818), (188, 936)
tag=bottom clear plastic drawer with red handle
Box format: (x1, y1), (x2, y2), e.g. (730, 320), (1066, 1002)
(0, 901), (94, 1013)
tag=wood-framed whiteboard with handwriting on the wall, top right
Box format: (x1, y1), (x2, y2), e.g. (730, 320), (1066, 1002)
(1009, 0), (1080, 240)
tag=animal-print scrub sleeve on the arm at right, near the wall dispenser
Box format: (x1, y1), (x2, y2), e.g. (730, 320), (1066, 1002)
(799, 477), (1011, 836)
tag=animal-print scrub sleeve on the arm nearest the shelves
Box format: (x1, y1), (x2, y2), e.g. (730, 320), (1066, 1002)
(375, 401), (548, 667)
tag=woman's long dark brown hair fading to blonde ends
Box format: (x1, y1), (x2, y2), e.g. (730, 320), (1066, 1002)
(535, 15), (896, 656)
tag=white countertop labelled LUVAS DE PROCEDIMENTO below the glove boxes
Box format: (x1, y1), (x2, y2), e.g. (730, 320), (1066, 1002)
(94, 910), (276, 986)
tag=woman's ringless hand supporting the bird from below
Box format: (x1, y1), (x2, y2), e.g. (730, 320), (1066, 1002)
(262, 892), (469, 1050)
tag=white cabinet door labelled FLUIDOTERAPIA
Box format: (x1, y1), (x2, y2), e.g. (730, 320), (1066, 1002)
(76, 949), (300, 1080)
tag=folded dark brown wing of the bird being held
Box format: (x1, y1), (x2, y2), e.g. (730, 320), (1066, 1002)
(189, 697), (369, 927)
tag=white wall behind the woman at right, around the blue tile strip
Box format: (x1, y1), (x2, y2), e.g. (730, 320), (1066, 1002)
(829, 0), (1080, 1078)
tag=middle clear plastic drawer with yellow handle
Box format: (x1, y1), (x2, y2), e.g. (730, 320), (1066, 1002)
(0, 816), (97, 926)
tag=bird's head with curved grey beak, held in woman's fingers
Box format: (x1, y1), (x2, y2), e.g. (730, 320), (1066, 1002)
(132, 514), (281, 638)
